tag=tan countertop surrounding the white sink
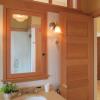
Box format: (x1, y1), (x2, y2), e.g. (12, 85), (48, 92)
(0, 91), (66, 100)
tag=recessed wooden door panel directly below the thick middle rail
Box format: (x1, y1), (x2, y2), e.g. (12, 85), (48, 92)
(67, 64), (88, 80)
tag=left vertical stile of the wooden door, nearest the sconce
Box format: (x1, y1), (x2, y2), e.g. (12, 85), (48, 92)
(60, 12), (67, 100)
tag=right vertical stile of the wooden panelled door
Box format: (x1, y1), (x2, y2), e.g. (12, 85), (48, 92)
(88, 17), (94, 100)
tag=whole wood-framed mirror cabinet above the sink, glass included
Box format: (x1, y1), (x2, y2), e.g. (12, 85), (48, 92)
(4, 9), (47, 81)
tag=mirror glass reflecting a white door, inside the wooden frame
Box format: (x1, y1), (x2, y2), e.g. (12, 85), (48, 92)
(11, 14), (41, 74)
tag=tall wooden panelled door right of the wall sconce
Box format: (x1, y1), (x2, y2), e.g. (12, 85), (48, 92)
(60, 13), (93, 100)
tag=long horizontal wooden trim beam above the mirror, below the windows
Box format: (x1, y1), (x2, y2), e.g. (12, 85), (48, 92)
(0, 0), (87, 15)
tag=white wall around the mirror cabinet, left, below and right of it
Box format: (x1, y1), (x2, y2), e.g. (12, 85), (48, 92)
(0, 6), (60, 87)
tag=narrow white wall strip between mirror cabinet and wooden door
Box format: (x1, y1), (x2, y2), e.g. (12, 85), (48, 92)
(48, 12), (60, 86)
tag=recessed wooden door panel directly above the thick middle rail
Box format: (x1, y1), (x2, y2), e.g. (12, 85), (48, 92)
(67, 43), (88, 59)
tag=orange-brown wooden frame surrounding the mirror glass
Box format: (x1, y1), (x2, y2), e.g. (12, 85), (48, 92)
(3, 8), (48, 82)
